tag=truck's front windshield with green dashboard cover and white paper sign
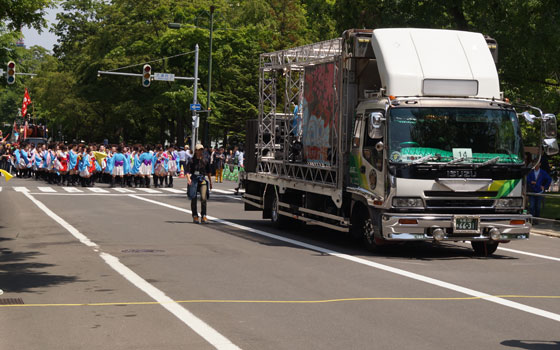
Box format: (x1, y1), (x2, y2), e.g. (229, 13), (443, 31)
(388, 107), (523, 164)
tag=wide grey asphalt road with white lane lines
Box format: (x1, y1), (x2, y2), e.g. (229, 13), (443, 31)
(0, 178), (560, 350)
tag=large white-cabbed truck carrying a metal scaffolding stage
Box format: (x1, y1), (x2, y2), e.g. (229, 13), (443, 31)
(243, 28), (558, 255)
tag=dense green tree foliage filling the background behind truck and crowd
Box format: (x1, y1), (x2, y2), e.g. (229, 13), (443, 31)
(4, 0), (560, 157)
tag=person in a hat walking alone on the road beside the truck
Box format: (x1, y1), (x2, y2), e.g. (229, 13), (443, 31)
(186, 144), (212, 223)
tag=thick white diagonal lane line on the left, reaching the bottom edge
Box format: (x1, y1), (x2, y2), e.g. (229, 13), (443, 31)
(22, 191), (240, 350)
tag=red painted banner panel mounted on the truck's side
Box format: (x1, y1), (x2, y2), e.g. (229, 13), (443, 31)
(301, 62), (336, 165)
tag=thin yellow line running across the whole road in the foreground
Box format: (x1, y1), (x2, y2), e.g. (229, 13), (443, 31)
(0, 295), (560, 308)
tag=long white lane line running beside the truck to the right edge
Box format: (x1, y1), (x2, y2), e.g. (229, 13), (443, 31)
(129, 194), (560, 322)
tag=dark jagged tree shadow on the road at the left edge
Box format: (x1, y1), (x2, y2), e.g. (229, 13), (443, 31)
(0, 249), (81, 293)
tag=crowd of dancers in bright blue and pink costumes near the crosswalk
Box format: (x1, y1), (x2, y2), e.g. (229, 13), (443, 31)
(6, 143), (180, 188)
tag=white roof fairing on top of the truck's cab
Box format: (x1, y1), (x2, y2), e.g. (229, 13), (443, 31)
(372, 28), (500, 99)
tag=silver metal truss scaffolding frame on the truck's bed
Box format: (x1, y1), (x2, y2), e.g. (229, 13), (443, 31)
(256, 38), (343, 190)
